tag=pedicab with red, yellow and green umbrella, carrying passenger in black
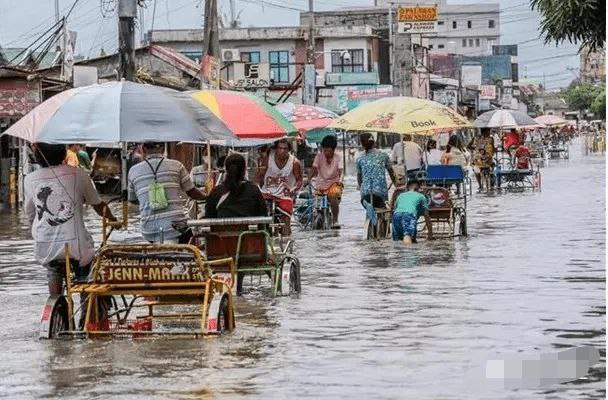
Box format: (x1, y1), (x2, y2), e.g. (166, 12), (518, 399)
(179, 90), (301, 296)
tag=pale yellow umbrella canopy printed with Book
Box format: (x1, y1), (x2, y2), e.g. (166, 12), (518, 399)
(328, 97), (471, 135)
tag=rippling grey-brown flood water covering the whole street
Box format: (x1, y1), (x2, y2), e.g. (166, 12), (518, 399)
(0, 138), (606, 399)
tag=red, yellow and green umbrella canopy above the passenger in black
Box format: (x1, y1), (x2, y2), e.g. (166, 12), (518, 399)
(188, 90), (298, 139)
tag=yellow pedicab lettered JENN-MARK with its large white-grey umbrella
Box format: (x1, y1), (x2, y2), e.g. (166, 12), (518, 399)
(5, 81), (245, 338)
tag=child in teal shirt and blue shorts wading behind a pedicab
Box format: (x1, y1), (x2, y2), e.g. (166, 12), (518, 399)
(391, 180), (433, 245)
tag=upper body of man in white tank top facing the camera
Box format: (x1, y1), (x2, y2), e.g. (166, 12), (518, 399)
(257, 139), (303, 197)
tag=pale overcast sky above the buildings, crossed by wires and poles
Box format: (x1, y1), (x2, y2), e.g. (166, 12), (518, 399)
(0, 0), (579, 89)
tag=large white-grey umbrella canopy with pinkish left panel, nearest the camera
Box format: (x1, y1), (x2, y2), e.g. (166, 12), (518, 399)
(5, 81), (234, 144)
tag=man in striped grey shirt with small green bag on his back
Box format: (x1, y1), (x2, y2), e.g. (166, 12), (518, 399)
(128, 143), (205, 243)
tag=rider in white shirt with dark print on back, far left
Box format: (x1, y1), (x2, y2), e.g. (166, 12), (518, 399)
(23, 143), (116, 301)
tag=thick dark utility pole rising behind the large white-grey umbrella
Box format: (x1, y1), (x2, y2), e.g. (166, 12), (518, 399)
(118, 0), (137, 81)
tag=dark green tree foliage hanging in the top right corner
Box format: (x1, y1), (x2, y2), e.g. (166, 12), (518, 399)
(530, 0), (606, 51)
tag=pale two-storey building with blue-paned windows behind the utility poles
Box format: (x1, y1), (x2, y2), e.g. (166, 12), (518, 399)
(148, 26), (379, 87)
